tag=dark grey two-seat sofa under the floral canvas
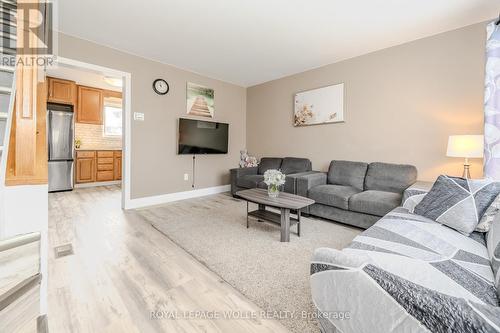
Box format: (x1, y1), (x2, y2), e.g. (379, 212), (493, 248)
(294, 161), (417, 229)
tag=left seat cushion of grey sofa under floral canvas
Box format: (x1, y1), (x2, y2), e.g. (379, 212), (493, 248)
(308, 185), (361, 210)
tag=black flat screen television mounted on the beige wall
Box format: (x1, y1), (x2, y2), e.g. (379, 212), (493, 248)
(177, 118), (229, 155)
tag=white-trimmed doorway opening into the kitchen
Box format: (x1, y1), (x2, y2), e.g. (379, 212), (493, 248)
(46, 57), (131, 209)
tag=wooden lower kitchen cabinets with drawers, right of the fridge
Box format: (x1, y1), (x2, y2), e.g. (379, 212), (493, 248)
(75, 150), (122, 184)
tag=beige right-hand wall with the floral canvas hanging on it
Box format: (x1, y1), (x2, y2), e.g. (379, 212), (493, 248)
(247, 24), (486, 180)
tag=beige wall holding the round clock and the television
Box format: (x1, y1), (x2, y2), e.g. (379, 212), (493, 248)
(59, 34), (246, 199)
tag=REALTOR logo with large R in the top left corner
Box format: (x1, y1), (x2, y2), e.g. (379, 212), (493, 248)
(0, 0), (56, 66)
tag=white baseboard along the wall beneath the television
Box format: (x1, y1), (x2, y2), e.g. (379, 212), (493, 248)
(125, 185), (231, 209)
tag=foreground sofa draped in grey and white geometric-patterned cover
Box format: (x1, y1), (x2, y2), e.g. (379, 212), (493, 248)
(310, 182), (500, 333)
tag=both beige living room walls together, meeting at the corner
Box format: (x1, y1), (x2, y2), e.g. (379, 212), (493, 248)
(59, 20), (485, 198)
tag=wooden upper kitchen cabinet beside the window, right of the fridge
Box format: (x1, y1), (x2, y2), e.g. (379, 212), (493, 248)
(76, 86), (104, 125)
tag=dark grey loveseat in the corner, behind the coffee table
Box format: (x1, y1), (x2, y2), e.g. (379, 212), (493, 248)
(230, 157), (318, 196)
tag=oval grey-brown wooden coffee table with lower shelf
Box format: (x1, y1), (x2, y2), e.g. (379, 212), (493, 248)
(236, 188), (314, 242)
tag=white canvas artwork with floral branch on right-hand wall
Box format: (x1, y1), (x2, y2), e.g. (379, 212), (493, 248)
(293, 83), (344, 126)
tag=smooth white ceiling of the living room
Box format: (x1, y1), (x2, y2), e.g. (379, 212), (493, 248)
(59, 0), (500, 86)
